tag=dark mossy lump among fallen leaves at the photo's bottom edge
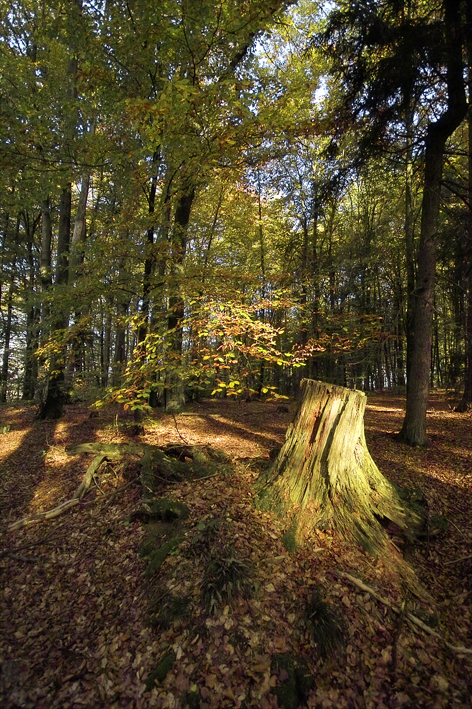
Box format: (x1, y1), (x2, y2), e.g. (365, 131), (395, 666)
(272, 652), (313, 709)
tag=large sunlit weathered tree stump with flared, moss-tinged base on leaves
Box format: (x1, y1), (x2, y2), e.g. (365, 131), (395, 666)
(256, 379), (413, 553)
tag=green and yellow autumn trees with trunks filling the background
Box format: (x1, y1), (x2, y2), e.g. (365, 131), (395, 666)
(0, 0), (472, 443)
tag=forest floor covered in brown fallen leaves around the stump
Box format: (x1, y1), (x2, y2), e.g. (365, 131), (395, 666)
(0, 393), (472, 709)
